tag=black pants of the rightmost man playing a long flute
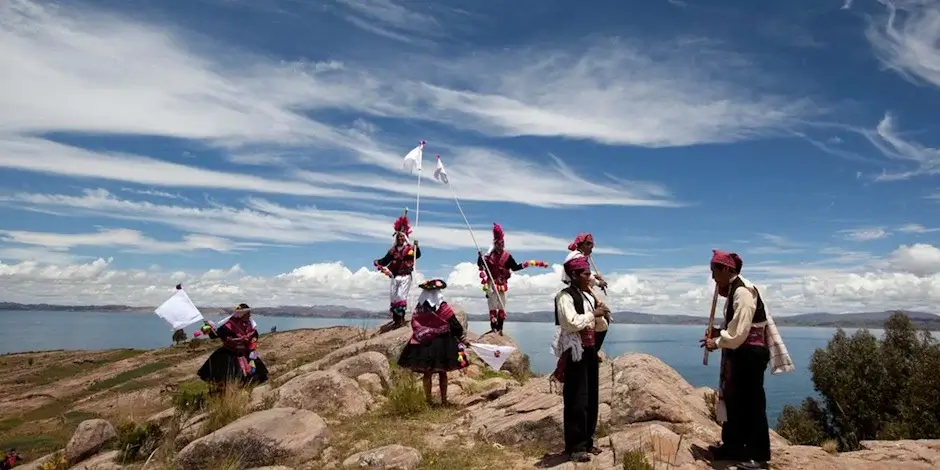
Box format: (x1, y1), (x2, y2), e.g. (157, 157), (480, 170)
(721, 346), (770, 462)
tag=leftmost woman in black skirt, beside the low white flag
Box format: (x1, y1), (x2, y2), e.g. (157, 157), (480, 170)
(198, 304), (268, 392)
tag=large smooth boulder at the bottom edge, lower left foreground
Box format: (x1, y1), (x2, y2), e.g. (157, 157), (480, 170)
(177, 408), (330, 470)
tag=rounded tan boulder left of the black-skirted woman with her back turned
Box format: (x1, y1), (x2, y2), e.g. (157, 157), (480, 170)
(274, 370), (375, 417)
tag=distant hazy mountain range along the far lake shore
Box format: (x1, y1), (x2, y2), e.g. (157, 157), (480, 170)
(0, 302), (940, 331)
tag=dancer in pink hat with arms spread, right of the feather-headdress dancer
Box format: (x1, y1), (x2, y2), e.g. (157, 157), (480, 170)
(477, 223), (525, 336)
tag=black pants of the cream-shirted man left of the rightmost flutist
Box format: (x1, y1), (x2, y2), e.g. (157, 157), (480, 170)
(562, 346), (599, 454)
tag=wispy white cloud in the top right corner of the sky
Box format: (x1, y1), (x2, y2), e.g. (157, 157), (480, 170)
(866, 0), (940, 87)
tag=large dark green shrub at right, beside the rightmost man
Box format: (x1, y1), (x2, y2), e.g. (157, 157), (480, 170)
(777, 313), (940, 451)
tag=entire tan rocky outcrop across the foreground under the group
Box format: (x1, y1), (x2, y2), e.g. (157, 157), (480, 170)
(17, 324), (940, 470)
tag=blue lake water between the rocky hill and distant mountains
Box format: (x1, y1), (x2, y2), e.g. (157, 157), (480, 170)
(0, 311), (860, 425)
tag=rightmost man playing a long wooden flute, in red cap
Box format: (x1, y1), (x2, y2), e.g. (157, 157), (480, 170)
(700, 250), (776, 469)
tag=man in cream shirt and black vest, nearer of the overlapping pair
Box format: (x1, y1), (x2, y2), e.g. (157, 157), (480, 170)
(552, 256), (609, 462)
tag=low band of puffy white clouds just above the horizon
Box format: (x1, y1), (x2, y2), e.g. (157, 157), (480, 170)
(0, 245), (940, 317)
